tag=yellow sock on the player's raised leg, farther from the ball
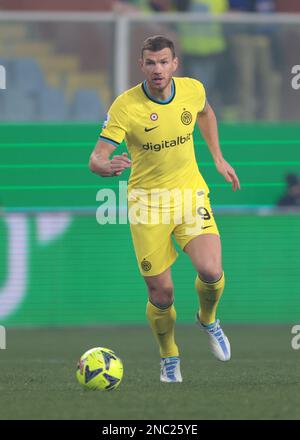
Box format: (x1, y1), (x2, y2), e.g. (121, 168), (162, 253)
(195, 272), (225, 325)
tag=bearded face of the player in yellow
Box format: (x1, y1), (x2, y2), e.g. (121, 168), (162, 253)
(140, 47), (178, 91)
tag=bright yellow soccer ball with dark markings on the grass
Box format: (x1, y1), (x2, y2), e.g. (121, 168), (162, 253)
(76, 347), (123, 391)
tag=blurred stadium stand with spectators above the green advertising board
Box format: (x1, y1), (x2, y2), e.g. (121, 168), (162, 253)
(0, 0), (300, 121)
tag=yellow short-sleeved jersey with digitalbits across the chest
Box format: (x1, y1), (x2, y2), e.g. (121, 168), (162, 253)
(99, 78), (208, 191)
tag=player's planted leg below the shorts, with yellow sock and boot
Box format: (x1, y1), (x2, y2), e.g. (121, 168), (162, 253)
(144, 268), (182, 382)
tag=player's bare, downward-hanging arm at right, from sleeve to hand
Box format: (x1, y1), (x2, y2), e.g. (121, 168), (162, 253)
(197, 102), (241, 191)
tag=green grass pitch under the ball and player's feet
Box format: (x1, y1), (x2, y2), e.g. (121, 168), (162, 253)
(0, 325), (300, 421)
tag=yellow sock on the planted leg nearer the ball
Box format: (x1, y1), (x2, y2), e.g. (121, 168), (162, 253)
(146, 301), (179, 357)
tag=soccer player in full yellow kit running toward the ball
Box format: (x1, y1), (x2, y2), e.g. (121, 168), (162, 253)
(90, 36), (240, 382)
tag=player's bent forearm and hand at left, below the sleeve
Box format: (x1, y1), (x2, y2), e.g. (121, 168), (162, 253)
(89, 139), (131, 177)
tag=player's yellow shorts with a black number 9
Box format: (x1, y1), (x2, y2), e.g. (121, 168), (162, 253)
(128, 191), (219, 276)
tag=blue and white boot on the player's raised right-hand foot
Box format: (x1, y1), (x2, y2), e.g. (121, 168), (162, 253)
(196, 313), (231, 362)
